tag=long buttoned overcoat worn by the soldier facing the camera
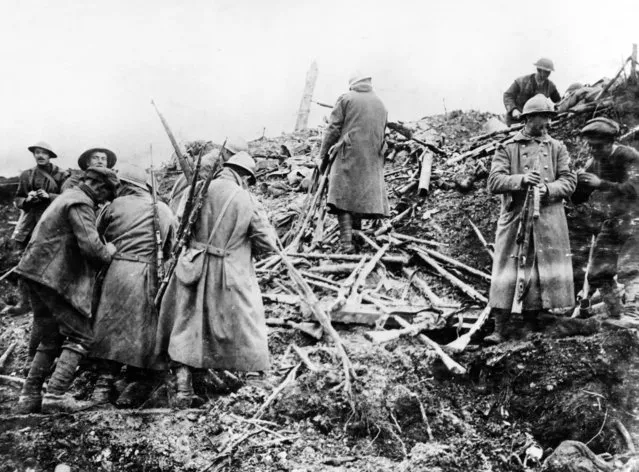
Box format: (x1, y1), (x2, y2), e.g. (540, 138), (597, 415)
(488, 132), (577, 310)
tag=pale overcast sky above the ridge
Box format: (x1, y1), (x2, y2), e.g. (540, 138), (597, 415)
(0, 0), (639, 175)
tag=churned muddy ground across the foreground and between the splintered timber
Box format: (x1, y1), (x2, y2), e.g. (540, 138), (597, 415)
(0, 90), (639, 472)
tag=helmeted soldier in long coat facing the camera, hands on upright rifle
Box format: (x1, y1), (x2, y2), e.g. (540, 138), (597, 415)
(486, 94), (577, 343)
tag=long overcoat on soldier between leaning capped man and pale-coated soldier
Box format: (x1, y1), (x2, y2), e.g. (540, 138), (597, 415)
(91, 186), (175, 369)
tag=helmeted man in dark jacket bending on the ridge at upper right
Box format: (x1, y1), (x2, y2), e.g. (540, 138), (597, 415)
(504, 57), (561, 125)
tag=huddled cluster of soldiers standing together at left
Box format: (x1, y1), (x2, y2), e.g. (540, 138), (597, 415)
(8, 139), (276, 413)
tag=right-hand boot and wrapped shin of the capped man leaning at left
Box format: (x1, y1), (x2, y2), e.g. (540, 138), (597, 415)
(42, 347), (94, 413)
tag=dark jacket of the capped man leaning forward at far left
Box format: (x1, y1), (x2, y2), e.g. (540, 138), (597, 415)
(16, 188), (111, 318)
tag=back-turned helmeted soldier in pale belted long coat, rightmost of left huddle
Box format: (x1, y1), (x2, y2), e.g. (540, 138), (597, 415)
(158, 152), (275, 407)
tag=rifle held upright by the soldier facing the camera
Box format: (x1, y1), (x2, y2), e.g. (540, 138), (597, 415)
(510, 155), (540, 314)
